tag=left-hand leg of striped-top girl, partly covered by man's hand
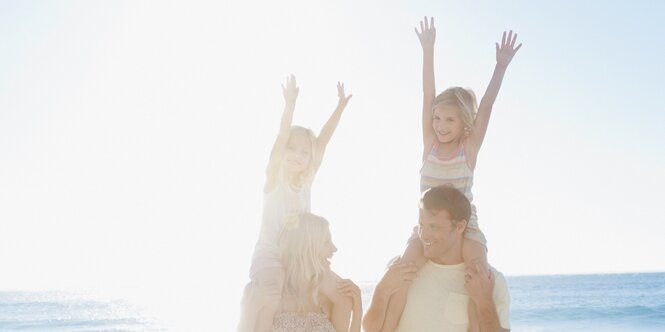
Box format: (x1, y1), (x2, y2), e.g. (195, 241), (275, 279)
(382, 228), (424, 331)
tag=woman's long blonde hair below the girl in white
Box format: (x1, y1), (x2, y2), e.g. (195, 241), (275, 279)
(279, 212), (330, 311)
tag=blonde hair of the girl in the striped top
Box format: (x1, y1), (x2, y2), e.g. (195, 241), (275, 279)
(432, 86), (478, 134)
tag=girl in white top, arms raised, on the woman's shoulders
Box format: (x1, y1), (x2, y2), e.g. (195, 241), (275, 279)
(239, 75), (352, 332)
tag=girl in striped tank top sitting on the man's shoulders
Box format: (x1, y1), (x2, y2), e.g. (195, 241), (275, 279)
(384, 17), (522, 331)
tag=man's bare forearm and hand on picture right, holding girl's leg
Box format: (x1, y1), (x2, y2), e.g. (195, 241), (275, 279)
(464, 263), (510, 332)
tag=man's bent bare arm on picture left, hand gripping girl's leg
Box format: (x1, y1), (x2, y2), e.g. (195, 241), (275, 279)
(363, 262), (418, 332)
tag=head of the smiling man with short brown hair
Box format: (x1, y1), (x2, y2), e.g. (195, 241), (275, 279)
(418, 185), (471, 265)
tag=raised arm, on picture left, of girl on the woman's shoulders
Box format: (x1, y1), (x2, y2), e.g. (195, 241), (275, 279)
(263, 75), (299, 192)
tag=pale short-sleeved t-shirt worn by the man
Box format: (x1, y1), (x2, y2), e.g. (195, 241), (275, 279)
(397, 261), (510, 332)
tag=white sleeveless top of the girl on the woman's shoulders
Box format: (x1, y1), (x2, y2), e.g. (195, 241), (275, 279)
(249, 183), (311, 278)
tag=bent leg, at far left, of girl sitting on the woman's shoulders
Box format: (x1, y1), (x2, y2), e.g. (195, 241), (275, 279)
(238, 268), (284, 332)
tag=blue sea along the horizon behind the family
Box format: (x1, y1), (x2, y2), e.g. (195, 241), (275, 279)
(0, 273), (665, 332)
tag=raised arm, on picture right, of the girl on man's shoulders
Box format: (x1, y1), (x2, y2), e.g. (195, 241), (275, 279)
(468, 30), (522, 165)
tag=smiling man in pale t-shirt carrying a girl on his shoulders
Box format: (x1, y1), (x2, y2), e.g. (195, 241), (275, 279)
(363, 186), (510, 332)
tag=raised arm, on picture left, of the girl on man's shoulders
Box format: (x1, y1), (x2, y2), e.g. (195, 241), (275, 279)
(414, 16), (436, 159)
